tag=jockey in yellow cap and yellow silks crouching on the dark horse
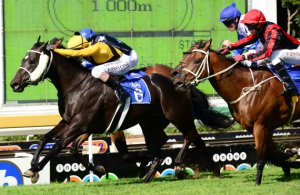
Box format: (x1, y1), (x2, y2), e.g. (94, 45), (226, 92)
(54, 35), (132, 104)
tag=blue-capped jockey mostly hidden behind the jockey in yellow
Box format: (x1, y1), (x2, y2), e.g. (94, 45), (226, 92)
(75, 28), (138, 71)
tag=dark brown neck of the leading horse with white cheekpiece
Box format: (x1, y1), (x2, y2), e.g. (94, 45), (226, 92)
(47, 53), (87, 94)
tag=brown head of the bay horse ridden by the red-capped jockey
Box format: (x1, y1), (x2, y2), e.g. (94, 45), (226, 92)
(171, 40), (212, 91)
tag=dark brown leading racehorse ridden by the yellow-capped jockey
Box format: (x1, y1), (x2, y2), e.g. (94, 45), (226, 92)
(10, 37), (233, 183)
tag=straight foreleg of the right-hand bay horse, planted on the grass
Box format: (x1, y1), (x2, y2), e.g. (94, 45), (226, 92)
(253, 124), (273, 185)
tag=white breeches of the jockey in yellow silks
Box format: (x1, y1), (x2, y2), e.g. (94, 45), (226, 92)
(92, 50), (138, 78)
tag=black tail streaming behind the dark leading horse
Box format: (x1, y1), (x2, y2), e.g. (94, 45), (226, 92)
(190, 87), (234, 129)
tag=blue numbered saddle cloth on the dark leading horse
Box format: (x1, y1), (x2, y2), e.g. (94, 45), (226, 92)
(120, 78), (151, 104)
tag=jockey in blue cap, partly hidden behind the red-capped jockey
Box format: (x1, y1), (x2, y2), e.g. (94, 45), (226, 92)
(219, 2), (262, 56)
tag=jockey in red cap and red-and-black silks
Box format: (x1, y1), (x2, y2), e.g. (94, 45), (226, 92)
(221, 9), (300, 95)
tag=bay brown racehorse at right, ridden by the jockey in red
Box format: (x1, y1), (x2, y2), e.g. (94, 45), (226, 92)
(172, 40), (300, 185)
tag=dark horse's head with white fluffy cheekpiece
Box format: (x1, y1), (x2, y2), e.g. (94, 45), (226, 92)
(10, 37), (51, 92)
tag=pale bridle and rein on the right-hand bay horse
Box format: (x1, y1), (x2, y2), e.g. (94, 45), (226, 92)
(182, 49), (238, 85)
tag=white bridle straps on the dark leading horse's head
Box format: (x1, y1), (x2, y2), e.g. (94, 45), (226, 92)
(19, 50), (53, 84)
